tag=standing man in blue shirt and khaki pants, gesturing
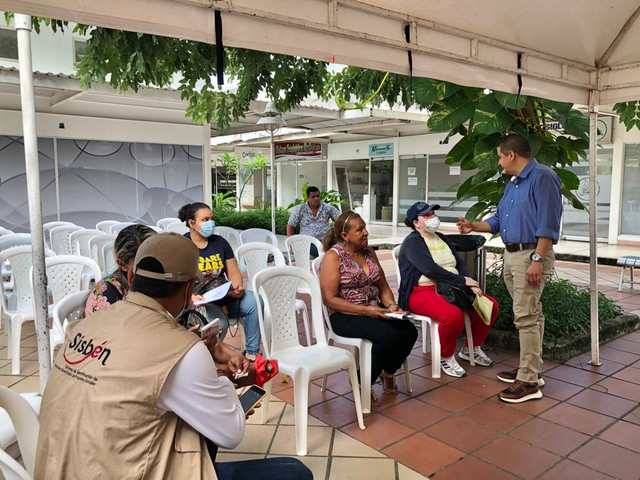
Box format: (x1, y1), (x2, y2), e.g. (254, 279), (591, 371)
(457, 135), (562, 403)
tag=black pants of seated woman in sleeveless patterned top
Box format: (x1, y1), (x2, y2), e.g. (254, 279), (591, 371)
(330, 312), (418, 384)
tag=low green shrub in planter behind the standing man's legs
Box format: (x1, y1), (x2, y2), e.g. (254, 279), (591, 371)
(486, 271), (623, 344)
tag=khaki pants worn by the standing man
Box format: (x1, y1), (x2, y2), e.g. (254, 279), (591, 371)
(504, 249), (555, 383)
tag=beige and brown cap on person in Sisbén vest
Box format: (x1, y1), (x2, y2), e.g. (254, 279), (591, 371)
(133, 232), (202, 282)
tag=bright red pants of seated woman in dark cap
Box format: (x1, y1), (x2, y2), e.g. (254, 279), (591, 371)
(409, 285), (498, 358)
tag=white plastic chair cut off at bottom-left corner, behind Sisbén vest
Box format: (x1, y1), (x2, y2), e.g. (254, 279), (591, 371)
(0, 387), (40, 480)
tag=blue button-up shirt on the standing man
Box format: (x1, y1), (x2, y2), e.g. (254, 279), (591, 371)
(486, 158), (562, 244)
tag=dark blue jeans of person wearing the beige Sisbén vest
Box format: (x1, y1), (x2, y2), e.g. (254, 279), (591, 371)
(213, 457), (313, 480)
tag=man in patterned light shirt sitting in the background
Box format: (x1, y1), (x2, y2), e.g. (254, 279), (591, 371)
(287, 186), (340, 258)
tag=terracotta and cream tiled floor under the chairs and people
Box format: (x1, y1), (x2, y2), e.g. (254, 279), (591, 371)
(5, 251), (640, 480)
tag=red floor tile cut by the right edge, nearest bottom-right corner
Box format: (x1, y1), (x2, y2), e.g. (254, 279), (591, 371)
(569, 439), (640, 480)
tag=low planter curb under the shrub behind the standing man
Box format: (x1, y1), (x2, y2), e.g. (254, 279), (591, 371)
(484, 313), (640, 363)
